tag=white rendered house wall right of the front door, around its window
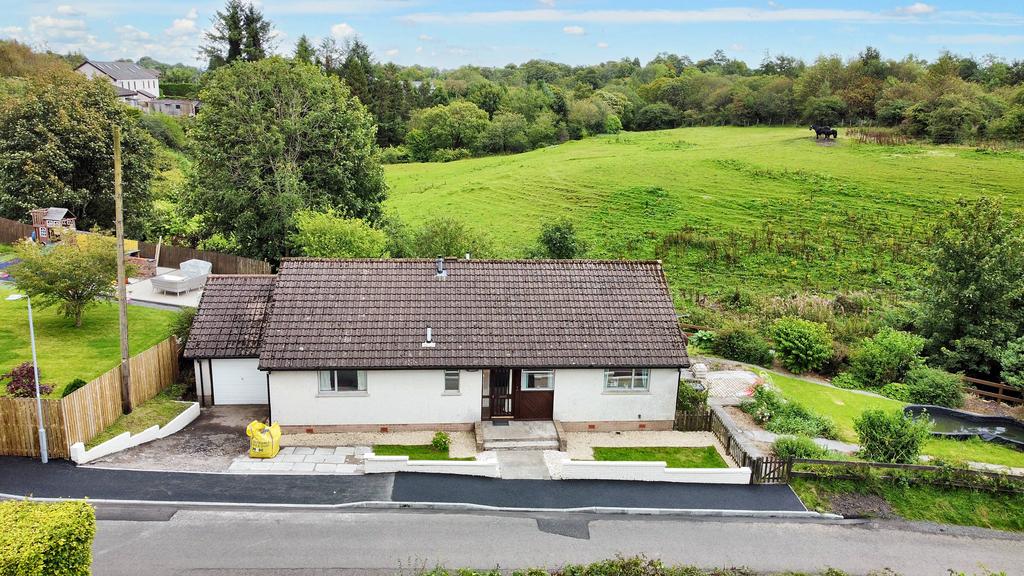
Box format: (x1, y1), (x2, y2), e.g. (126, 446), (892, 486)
(553, 368), (679, 422)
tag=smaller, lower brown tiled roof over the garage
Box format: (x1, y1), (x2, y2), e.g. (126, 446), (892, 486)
(185, 275), (274, 358)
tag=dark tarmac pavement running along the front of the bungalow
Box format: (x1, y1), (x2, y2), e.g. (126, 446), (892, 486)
(0, 457), (805, 511)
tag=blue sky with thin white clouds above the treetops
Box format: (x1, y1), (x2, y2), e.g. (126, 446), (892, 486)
(0, 0), (1024, 68)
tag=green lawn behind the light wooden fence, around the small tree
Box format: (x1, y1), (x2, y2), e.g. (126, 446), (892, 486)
(0, 283), (175, 398)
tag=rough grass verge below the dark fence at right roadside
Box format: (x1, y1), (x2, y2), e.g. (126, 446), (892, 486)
(791, 479), (1024, 532)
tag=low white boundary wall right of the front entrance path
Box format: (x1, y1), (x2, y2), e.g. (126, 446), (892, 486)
(545, 452), (751, 484)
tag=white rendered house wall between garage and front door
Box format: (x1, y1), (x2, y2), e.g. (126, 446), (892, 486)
(268, 370), (482, 426)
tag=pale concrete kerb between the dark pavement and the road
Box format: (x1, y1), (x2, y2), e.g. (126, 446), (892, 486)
(0, 493), (845, 522)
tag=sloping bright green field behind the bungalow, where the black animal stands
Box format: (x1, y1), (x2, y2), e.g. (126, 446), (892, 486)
(387, 127), (1024, 305)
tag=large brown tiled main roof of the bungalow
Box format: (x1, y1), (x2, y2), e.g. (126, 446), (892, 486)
(260, 258), (689, 370)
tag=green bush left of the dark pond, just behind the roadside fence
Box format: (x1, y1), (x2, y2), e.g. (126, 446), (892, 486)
(853, 410), (932, 464)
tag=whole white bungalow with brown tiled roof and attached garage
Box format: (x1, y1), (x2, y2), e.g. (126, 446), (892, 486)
(185, 258), (689, 433)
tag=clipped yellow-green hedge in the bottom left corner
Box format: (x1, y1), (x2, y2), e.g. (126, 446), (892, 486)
(0, 500), (96, 576)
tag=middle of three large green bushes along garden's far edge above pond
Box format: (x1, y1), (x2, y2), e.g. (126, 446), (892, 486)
(850, 328), (925, 387)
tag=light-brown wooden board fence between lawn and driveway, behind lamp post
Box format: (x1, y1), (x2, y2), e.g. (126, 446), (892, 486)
(0, 336), (180, 458)
